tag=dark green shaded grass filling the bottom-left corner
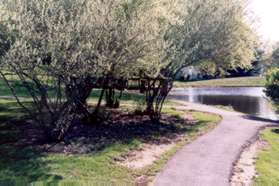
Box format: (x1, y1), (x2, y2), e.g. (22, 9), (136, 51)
(0, 143), (62, 185)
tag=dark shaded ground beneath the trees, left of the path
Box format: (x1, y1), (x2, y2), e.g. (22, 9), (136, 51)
(50, 111), (199, 154)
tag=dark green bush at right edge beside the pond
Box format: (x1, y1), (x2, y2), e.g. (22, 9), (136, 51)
(266, 68), (279, 102)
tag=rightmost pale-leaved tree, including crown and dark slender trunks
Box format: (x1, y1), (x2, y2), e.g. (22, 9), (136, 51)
(142, 0), (256, 118)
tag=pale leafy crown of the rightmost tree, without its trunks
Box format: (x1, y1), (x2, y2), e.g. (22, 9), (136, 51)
(167, 0), (256, 77)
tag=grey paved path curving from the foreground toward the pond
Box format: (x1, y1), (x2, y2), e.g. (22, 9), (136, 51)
(154, 103), (274, 186)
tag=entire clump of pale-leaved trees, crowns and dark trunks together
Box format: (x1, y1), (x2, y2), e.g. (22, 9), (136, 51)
(0, 0), (256, 139)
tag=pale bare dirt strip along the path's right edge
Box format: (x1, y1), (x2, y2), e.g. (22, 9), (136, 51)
(231, 139), (268, 186)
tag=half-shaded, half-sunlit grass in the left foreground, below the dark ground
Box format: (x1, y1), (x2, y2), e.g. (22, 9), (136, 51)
(0, 140), (138, 185)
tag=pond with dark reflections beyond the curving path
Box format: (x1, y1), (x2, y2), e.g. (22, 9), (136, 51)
(170, 87), (279, 120)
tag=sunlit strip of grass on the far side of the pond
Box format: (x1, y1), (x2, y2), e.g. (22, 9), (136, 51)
(174, 77), (265, 88)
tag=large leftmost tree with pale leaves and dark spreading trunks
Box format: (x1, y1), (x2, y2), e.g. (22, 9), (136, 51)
(0, 0), (170, 140)
